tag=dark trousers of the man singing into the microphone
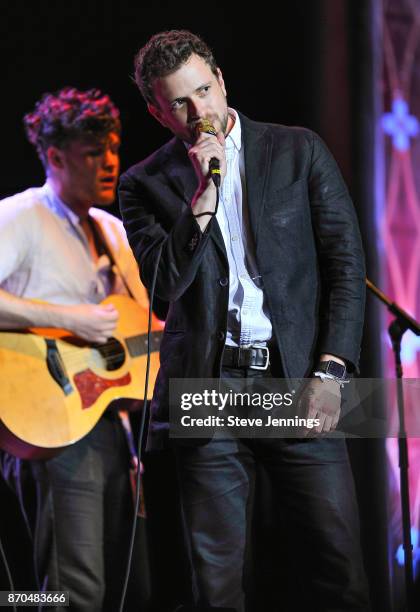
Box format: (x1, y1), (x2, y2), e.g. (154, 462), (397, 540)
(176, 369), (370, 612)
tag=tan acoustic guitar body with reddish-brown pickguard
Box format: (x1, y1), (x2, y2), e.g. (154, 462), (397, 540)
(0, 295), (162, 459)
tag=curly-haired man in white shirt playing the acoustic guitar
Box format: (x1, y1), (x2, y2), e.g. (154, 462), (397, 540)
(0, 88), (148, 612)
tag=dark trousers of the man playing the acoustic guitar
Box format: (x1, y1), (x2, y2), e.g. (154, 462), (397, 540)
(2, 413), (147, 612)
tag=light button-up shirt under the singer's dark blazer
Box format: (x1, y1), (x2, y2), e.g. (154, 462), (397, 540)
(216, 109), (272, 346)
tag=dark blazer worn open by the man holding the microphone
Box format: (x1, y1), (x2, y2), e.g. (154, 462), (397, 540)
(119, 115), (365, 446)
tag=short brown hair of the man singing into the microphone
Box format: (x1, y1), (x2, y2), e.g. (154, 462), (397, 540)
(134, 30), (217, 104)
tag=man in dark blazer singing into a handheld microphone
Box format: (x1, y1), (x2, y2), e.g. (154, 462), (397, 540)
(120, 31), (369, 612)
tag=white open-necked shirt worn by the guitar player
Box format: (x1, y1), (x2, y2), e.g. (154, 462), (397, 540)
(0, 183), (148, 308)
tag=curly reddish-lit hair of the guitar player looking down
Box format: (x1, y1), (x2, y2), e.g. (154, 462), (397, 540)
(23, 87), (121, 168)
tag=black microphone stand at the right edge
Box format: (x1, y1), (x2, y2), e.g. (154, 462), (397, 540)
(366, 278), (420, 612)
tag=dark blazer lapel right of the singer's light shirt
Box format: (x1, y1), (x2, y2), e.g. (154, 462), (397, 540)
(240, 114), (272, 246)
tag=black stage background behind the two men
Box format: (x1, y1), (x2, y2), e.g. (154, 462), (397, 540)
(0, 0), (390, 612)
